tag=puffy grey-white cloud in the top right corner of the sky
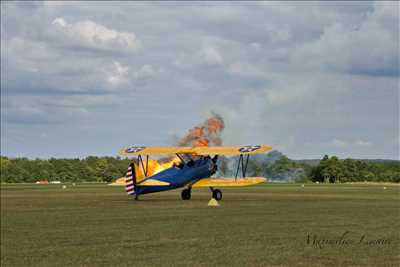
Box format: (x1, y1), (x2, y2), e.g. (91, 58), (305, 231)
(291, 2), (399, 76)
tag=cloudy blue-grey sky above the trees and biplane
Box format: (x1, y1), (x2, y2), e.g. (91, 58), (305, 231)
(1, 1), (400, 159)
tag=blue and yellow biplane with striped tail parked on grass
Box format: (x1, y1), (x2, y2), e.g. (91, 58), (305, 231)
(119, 145), (272, 200)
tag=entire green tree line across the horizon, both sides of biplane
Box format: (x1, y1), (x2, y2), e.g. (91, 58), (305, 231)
(0, 151), (400, 183)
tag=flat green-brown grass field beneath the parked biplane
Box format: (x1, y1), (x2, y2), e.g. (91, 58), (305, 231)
(1, 184), (400, 266)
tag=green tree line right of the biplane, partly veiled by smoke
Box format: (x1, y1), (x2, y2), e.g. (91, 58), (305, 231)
(220, 151), (400, 183)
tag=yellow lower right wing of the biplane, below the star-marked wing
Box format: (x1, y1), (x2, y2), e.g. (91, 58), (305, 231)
(192, 177), (267, 187)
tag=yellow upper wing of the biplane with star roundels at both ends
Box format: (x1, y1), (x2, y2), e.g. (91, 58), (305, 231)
(119, 145), (272, 156)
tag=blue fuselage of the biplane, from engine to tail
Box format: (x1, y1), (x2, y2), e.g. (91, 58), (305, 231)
(135, 157), (215, 195)
